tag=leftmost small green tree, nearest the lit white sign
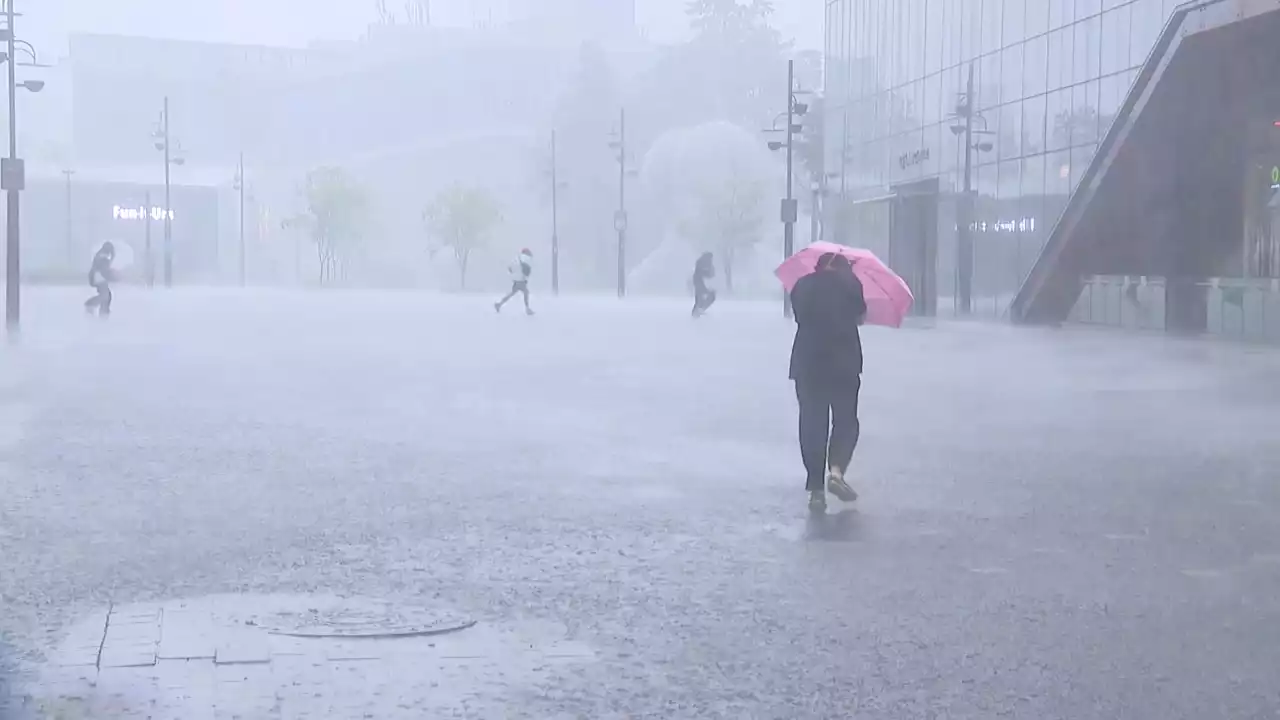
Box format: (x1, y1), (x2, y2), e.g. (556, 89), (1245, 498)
(283, 167), (369, 284)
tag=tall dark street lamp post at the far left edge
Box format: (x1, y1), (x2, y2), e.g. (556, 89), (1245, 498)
(0, 0), (47, 337)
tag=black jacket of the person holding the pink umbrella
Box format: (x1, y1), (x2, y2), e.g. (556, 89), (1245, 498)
(790, 269), (867, 380)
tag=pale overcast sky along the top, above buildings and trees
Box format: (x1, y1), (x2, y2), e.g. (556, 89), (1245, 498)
(24, 0), (823, 55)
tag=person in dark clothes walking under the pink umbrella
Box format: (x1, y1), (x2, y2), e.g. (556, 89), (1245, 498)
(791, 252), (867, 511)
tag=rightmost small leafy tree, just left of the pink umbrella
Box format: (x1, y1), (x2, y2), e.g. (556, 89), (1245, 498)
(684, 172), (767, 292)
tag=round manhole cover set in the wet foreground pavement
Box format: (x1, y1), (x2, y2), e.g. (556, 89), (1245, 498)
(247, 601), (476, 638)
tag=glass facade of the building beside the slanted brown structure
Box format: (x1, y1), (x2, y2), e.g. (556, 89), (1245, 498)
(824, 0), (1181, 315)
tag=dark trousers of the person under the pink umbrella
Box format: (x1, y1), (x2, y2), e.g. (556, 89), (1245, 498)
(795, 375), (863, 491)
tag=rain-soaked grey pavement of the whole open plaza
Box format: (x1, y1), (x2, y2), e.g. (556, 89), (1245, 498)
(0, 288), (1280, 720)
